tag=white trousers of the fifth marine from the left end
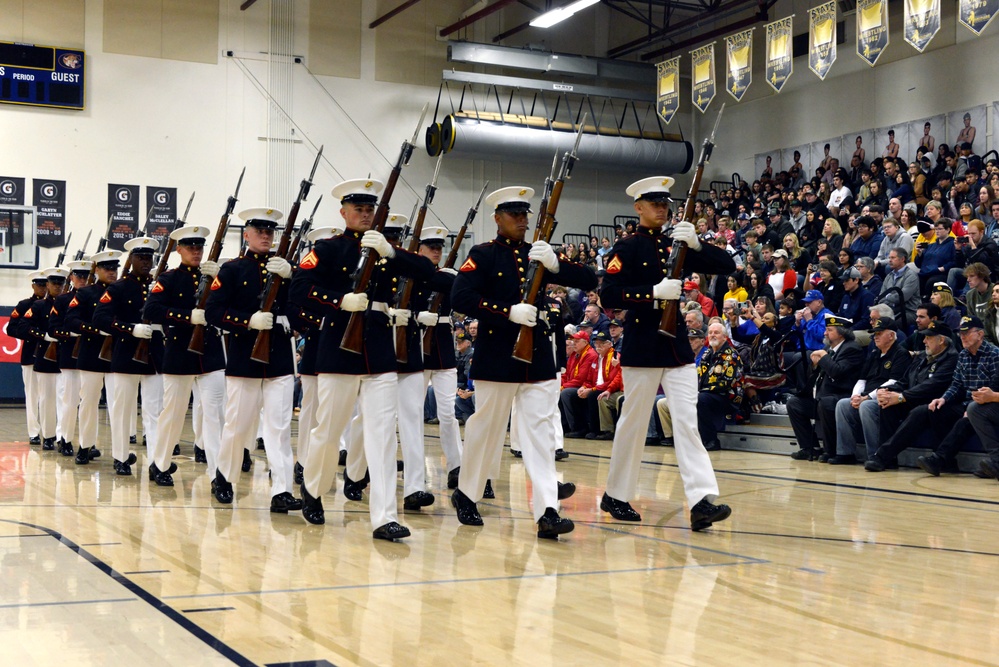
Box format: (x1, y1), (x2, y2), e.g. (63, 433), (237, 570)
(108, 373), (162, 461)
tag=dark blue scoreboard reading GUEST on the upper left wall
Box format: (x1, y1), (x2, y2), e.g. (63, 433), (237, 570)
(0, 42), (84, 109)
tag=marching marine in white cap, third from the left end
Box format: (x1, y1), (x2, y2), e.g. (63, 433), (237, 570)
(46, 260), (91, 456)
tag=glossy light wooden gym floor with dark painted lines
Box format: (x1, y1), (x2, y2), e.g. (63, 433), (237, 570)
(0, 402), (999, 667)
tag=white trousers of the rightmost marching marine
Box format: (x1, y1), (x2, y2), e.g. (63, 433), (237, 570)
(607, 364), (718, 507)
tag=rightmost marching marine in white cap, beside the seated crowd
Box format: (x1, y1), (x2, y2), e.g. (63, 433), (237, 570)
(600, 176), (735, 531)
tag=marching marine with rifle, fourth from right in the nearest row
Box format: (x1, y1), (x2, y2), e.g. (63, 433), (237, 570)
(205, 208), (302, 514)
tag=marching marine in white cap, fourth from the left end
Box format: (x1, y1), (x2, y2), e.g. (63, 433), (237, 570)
(66, 250), (121, 465)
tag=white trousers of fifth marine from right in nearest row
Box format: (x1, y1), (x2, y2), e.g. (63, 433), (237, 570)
(156, 370), (225, 477)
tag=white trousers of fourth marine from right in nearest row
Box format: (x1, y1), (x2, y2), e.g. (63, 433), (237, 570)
(218, 375), (295, 496)
